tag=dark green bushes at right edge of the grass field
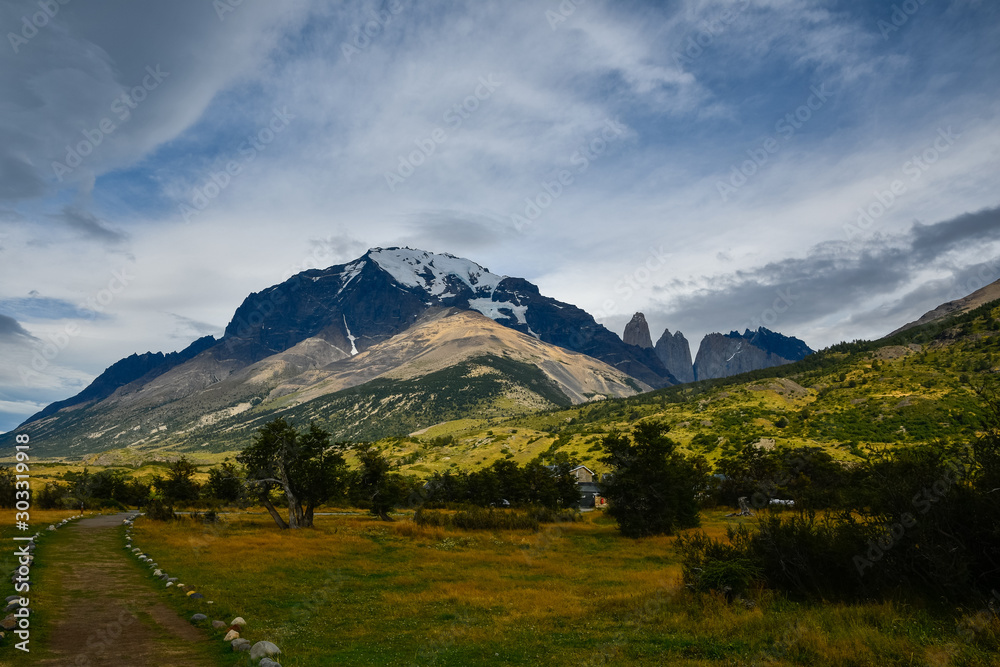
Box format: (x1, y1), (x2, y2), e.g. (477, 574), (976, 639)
(682, 385), (1000, 604)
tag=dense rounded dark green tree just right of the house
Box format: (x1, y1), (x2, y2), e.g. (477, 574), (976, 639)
(601, 421), (707, 537)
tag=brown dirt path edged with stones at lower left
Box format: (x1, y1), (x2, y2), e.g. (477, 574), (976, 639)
(32, 514), (219, 667)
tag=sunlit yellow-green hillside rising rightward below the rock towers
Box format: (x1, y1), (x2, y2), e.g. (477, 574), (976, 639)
(370, 302), (1000, 472)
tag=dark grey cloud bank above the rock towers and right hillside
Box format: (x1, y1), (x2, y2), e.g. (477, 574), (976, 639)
(657, 209), (1000, 344)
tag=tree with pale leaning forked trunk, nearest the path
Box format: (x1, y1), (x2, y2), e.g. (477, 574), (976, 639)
(236, 418), (347, 530)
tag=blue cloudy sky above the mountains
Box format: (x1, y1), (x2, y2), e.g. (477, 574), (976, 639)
(0, 0), (1000, 432)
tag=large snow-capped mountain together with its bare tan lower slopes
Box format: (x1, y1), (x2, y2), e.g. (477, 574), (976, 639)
(7, 248), (676, 453)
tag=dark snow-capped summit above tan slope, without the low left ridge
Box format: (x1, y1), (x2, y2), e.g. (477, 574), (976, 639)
(222, 248), (675, 387)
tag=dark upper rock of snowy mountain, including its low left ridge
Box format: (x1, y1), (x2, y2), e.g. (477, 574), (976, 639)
(25, 248), (676, 430)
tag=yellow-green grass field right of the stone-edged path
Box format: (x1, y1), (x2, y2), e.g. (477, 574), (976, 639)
(123, 512), (997, 667)
